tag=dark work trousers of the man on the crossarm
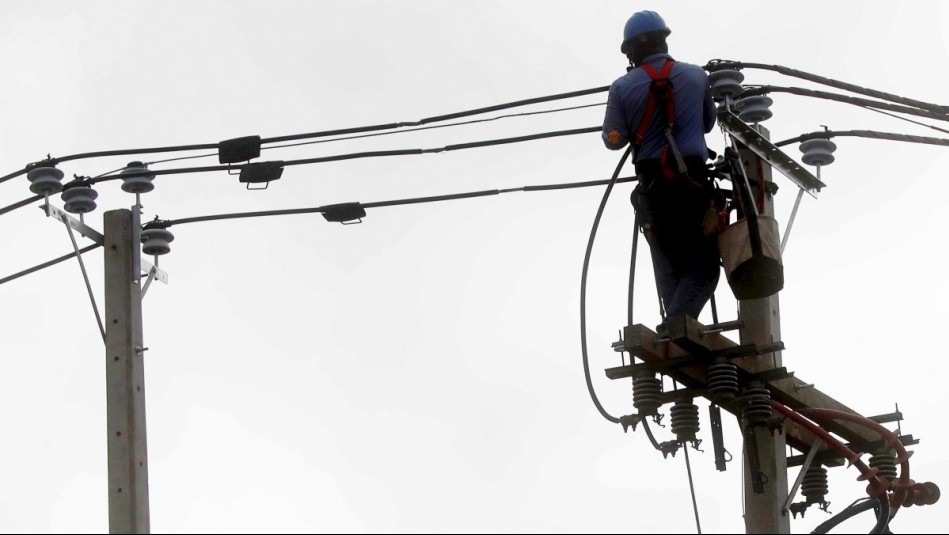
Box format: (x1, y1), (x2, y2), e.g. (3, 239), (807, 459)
(636, 157), (721, 318)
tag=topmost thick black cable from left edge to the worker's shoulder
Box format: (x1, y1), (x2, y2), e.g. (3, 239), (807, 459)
(0, 86), (609, 183)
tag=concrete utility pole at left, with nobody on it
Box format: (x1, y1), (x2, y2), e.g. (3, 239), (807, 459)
(103, 210), (150, 533)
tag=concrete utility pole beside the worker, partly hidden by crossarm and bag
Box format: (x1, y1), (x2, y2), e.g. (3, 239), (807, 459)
(738, 125), (791, 533)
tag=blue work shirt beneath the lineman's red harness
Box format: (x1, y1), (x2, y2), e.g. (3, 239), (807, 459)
(603, 53), (715, 162)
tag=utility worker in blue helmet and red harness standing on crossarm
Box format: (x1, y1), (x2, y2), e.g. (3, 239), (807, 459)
(603, 11), (720, 331)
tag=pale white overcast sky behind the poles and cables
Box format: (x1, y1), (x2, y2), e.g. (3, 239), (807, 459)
(0, 0), (949, 533)
